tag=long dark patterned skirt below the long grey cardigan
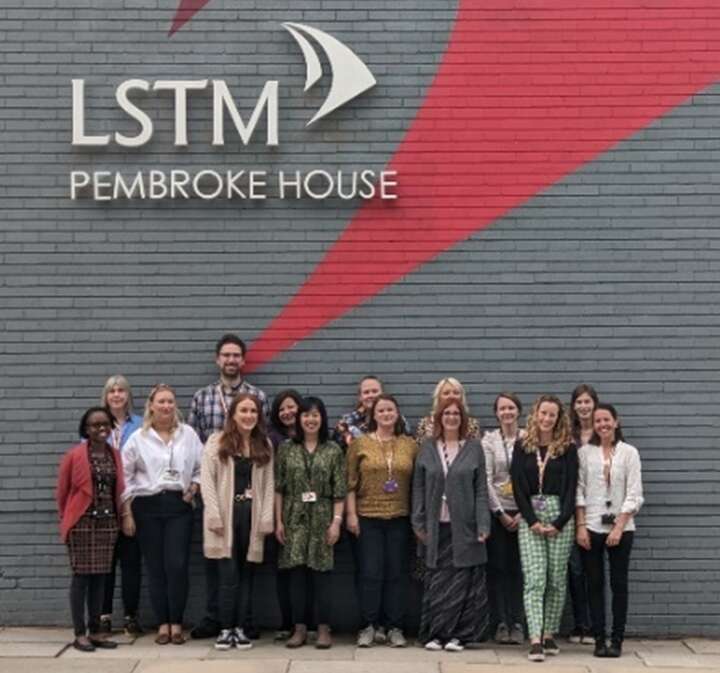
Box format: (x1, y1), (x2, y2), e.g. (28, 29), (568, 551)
(418, 524), (489, 643)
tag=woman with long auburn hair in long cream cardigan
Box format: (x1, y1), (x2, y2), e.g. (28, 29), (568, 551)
(201, 393), (274, 650)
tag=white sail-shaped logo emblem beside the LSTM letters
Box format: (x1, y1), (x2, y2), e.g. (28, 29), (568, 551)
(282, 23), (376, 126)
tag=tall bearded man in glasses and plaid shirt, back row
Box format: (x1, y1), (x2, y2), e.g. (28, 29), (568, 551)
(187, 334), (270, 638)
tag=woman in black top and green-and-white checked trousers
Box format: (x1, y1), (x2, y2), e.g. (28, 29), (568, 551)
(511, 395), (578, 661)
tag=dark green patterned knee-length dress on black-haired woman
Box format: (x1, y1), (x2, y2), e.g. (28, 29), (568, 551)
(275, 441), (347, 572)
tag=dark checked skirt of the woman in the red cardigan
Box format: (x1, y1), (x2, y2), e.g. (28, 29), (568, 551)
(67, 514), (118, 575)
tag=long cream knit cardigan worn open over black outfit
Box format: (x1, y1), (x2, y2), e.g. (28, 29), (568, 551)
(200, 432), (275, 563)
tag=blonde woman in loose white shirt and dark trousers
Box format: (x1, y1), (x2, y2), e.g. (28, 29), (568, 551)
(122, 383), (203, 645)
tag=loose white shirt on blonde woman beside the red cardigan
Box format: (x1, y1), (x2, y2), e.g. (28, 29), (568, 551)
(122, 424), (203, 501)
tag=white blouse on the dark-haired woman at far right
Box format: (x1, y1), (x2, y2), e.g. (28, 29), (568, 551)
(575, 442), (644, 533)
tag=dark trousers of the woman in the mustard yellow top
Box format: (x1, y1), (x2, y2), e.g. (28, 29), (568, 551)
(358, 516), (410, 629)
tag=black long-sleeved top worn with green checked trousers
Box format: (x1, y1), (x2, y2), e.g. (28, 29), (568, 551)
(510, 439), (578, 530)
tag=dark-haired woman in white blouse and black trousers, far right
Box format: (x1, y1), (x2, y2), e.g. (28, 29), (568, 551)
(575, 403), (643, 657)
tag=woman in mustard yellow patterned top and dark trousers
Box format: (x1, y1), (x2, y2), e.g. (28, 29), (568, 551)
(346, 394), (417, 647)
